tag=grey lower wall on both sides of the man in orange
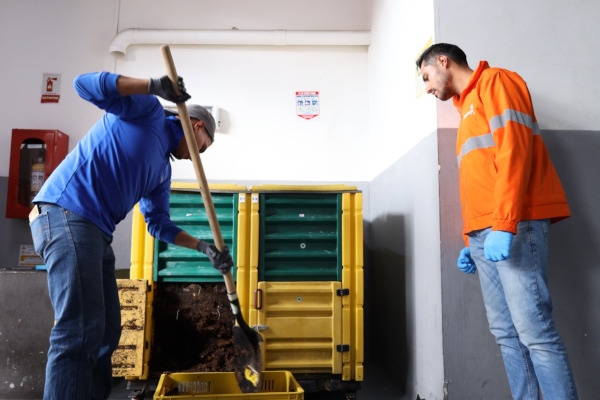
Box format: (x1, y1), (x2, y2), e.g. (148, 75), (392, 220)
(438, 129), (600, 400)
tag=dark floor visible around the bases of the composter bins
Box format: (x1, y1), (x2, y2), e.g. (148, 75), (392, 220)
(109, 366), (414, 400)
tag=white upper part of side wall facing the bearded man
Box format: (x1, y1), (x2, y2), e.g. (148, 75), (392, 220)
(369, 0), (436, 178)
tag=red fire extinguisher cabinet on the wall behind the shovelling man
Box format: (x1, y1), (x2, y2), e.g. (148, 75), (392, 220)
(6, 129), (69, 218)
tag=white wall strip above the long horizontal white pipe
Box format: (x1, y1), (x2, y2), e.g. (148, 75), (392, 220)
(119, 0), (372, 31)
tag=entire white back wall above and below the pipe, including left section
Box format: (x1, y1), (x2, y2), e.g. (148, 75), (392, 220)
(0, 0), (371, 181)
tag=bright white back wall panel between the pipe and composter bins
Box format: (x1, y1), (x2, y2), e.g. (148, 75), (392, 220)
(117, 46), (369, 181)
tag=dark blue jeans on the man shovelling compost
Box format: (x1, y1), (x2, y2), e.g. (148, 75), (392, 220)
(30, 203), (121, 400)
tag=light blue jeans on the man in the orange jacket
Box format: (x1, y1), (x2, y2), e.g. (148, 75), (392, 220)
(469, 220), (577, 400)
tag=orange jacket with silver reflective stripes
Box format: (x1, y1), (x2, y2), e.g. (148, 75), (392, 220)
(454, 61), (570, 244)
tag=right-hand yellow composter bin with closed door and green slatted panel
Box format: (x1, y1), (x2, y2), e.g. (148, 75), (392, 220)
(249, 185), (364, 392)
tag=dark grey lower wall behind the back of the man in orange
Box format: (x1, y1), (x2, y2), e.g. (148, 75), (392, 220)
(542, 131), (600, 399)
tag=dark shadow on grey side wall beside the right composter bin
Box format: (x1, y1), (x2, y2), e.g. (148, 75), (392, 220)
(364, 215), (408, 394)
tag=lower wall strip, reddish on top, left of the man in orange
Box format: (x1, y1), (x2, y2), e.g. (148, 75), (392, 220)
(438, 129), (510, 399)
